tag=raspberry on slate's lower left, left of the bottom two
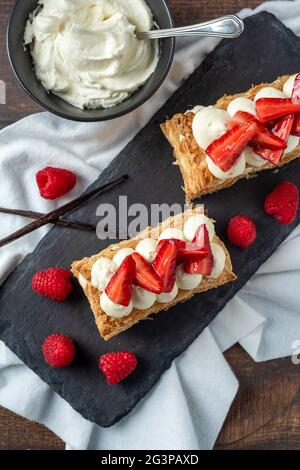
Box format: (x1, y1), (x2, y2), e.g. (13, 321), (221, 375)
(42, 334), (75, 367)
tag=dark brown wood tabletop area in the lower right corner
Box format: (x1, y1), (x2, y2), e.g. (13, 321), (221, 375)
(216, 346), (300, 450)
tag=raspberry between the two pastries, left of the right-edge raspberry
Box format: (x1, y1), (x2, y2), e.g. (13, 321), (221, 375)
(227, 215), (256, 248)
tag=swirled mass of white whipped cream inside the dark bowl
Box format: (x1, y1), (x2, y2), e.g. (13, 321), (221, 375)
(24, 0), (159, 109)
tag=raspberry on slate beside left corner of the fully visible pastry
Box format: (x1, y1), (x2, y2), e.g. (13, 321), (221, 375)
(31, 268), (72, 302)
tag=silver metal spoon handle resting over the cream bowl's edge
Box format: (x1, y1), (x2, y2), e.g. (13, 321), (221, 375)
(136, 15), (244, 39)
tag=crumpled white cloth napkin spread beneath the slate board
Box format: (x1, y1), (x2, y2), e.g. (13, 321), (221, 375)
(0, 0), (300, 450)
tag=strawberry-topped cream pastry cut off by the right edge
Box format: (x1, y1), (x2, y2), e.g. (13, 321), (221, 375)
(161, 74), (300, 201)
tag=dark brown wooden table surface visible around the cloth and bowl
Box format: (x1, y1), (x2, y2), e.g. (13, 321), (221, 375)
(0, 0), (300, 450)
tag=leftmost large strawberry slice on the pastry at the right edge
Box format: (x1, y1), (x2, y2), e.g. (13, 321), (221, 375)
(206, 123), (256, 171)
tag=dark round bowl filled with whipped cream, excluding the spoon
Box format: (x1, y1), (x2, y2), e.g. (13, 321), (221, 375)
(8, 0), (175, 121)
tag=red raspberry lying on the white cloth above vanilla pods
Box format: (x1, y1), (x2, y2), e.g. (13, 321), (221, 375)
(35, 166), (76, 199)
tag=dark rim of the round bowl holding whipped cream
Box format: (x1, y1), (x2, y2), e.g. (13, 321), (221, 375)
(6, 0), (175, 122)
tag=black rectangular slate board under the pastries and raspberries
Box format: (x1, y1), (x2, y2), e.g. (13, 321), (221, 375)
(0, 13), (300, 427)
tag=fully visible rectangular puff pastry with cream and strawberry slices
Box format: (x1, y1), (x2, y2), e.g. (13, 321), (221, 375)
(72, 207), (236, 340)
